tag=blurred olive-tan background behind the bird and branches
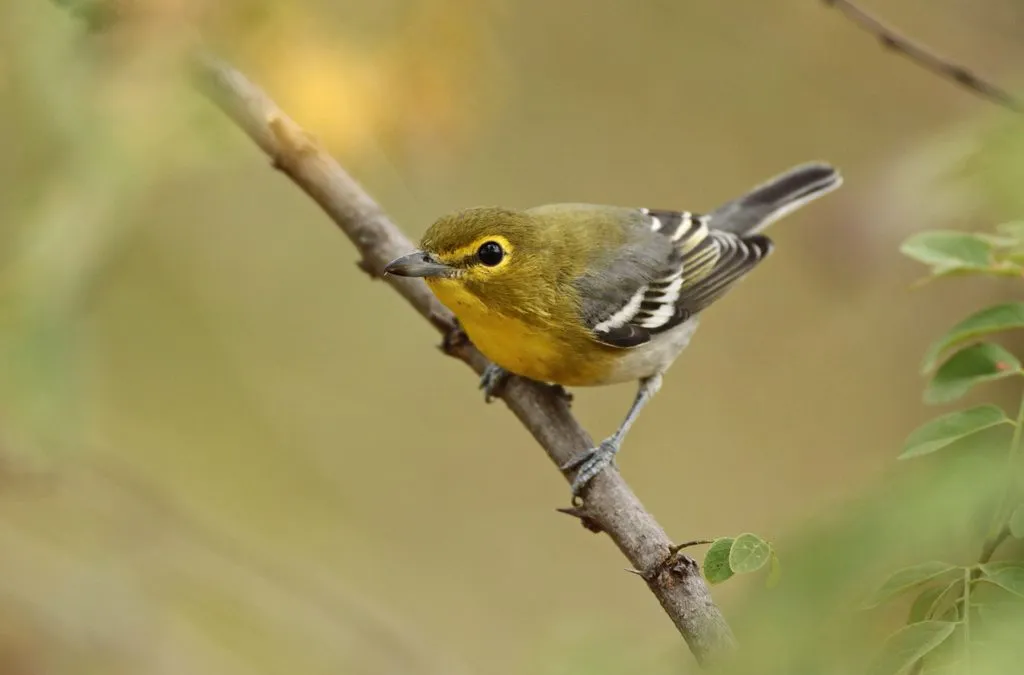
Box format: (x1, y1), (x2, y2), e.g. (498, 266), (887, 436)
(0, 0), (1024, 675)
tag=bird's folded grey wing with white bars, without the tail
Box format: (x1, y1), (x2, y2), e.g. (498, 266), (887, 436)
(577, 209), (772, 347)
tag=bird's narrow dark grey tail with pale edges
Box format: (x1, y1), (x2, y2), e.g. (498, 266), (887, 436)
(711, 162), (843, 236)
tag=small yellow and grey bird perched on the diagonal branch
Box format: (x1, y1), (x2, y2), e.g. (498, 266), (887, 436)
(385, 162), (843, 501)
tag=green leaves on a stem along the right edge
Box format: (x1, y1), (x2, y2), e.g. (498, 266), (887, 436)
(865, 222), (1024, 675)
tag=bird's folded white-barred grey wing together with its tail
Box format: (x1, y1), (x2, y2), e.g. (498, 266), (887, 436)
(579, 162), (843, 347)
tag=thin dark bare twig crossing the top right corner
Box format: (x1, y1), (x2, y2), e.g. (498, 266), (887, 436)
(822, 0), (1024, 113)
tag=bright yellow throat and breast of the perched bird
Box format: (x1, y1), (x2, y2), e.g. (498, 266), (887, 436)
(428, 280), (610, 386)
